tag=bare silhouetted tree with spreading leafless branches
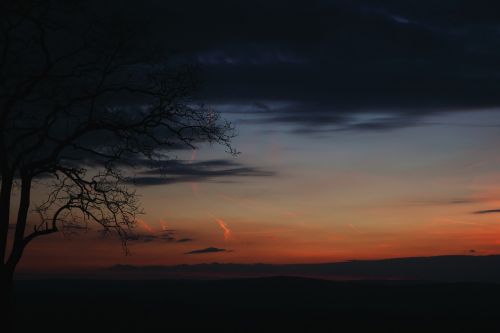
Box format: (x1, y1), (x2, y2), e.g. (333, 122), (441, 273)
(0, 0), (233, 326)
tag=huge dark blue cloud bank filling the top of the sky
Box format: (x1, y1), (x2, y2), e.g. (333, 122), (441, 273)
(102, 0), (500, 133)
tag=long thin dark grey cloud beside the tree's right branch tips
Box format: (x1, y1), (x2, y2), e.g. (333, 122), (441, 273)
(130, 160), (275, 186)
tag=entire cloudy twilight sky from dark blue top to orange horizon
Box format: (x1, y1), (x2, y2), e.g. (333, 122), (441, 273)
(15, 0), (500, 271)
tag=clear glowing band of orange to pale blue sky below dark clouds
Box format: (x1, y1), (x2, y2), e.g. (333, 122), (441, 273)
(12, 112), (500, 271)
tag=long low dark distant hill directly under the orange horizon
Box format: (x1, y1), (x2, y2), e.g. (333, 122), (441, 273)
(103, 255), (500, 282)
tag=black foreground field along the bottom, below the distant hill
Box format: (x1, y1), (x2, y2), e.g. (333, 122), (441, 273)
(16, 277), (500, 332)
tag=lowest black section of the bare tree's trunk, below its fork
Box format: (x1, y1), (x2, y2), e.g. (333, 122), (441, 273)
(0, 267), (14, 333)
